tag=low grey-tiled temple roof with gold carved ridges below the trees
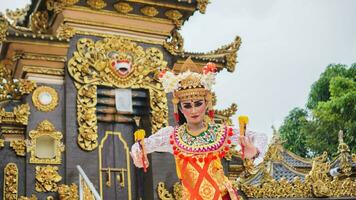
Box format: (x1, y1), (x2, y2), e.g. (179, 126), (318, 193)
(238, 132), (356, 198)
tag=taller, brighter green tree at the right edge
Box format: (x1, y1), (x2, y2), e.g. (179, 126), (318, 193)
(306, 75), (356, 154)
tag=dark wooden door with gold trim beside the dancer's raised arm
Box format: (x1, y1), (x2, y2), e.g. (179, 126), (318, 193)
(97, 88), (150, 200)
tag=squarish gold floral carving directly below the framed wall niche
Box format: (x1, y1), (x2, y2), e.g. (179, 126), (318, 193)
(35, 165), (62, 192)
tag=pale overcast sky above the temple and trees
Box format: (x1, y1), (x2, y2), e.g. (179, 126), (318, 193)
(0, 0), (356, 141)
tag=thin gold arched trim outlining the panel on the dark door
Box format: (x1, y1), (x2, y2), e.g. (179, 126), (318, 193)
(98, 131), (132, 200)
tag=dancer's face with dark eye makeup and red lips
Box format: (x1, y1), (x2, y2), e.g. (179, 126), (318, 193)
(180, 99), (206, 124)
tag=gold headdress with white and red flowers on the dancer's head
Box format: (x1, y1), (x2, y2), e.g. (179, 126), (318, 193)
(160, 57), (216, 122)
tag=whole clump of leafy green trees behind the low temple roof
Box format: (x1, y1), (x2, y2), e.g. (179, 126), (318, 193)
(279, 63), (356, 156)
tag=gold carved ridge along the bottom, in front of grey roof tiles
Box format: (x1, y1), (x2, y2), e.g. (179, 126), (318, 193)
(241, 152), (356, 198)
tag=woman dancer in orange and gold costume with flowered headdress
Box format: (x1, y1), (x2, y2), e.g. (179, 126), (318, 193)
(131, 58), (267, 200)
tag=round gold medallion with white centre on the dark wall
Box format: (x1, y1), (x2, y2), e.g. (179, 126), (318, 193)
(32, 86), (59, 112)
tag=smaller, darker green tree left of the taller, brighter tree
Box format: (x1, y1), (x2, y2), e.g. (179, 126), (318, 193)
(279, 108), (308, 157)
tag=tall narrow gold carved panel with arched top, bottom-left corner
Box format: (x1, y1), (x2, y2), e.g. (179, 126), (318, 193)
(3, 163), (19, 200)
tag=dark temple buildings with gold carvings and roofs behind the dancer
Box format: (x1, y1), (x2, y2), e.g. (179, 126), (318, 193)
(0, 0), (356, 200)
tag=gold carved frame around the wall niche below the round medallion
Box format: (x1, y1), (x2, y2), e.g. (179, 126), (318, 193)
(27, 120), (64, 164)
